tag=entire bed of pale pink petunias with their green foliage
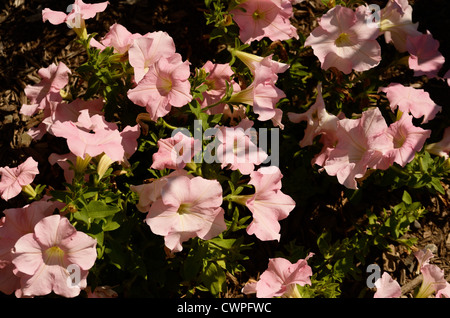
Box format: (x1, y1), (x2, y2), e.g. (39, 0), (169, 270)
(0, 0), (450, 298)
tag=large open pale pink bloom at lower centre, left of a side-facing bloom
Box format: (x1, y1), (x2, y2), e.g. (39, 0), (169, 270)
(145, 176), (226, 252)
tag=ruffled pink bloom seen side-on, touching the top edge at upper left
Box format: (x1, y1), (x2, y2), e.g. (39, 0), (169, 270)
(42, 0), (109, 27)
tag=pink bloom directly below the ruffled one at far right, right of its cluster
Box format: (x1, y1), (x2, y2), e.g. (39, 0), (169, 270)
(386, 114), (431, 167)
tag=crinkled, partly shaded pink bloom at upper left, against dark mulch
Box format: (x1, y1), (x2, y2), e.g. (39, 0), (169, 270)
(20, 62), (71, 116)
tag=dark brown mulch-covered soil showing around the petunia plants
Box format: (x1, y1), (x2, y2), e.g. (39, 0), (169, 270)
(0, 0), (450, 297)
